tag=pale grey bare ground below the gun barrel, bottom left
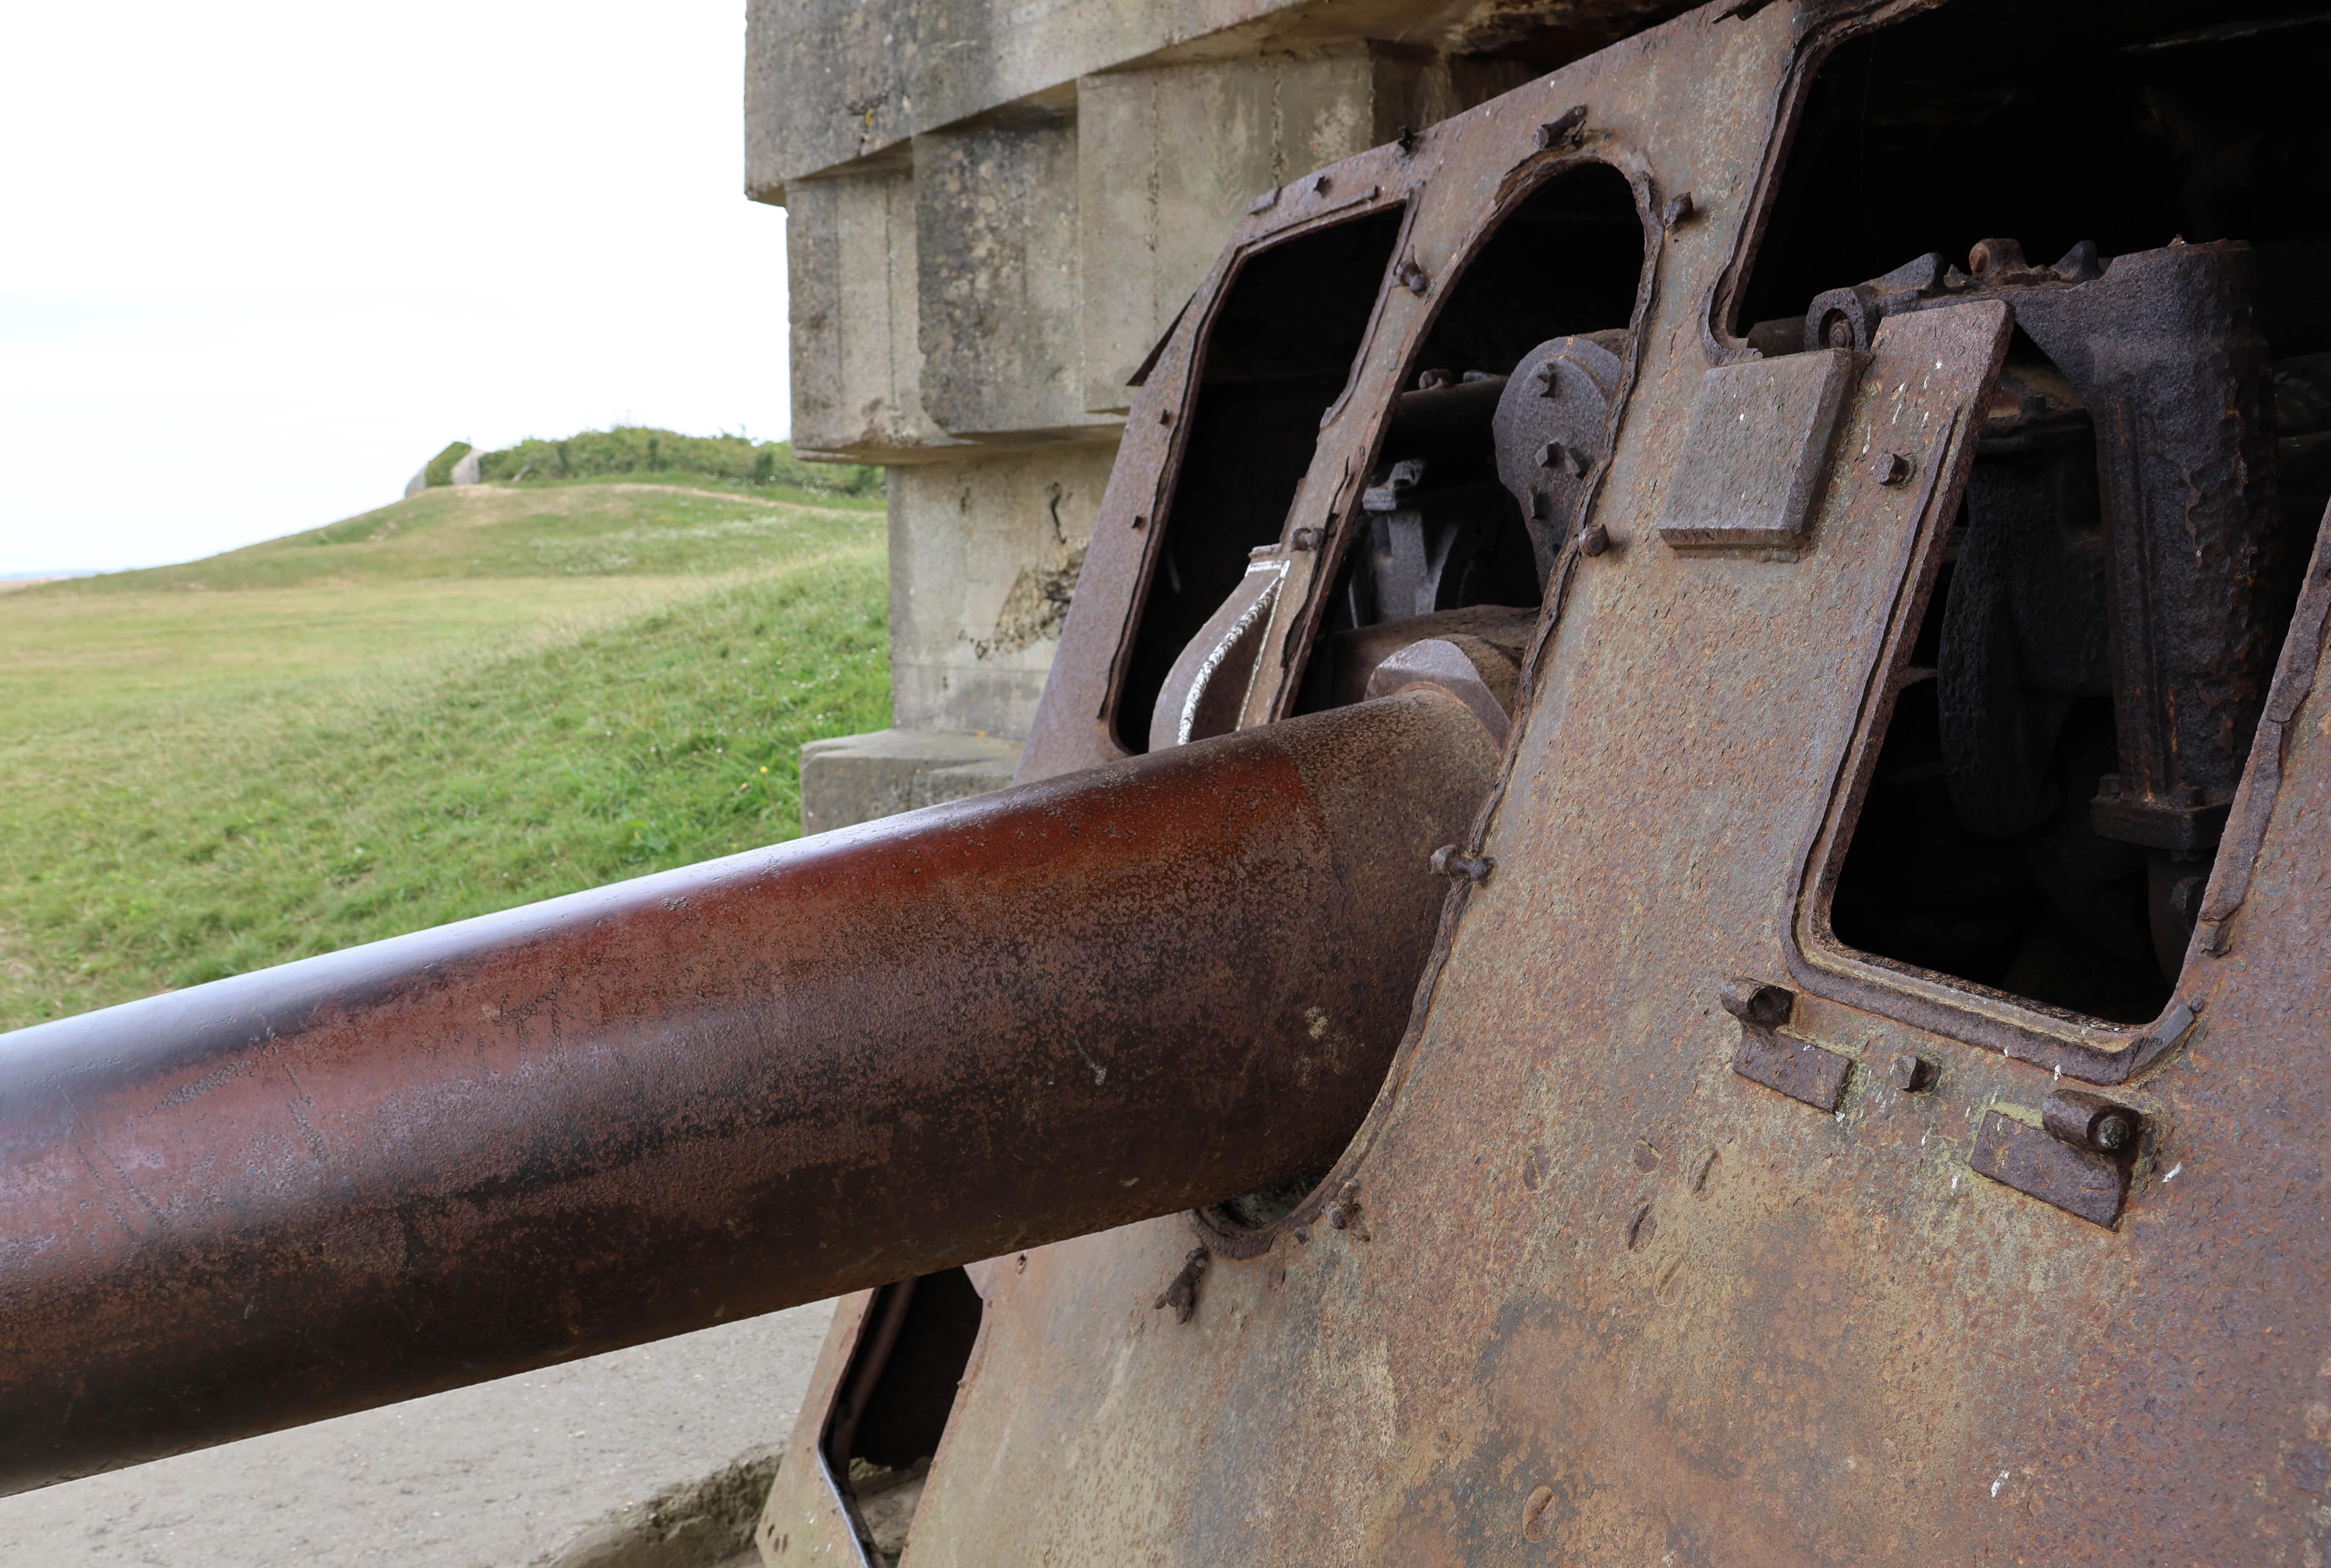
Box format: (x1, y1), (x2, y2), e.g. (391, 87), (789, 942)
(0, 1303), (832, 1568)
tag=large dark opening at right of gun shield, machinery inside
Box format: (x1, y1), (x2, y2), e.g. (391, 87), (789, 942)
(1739, 0), (2331, 1053)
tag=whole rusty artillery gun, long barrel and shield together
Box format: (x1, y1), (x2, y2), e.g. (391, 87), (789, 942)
(0, 0), (2331, 1568)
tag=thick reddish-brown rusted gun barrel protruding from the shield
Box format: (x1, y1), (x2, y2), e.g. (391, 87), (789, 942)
(0, 692), (1496, 1489)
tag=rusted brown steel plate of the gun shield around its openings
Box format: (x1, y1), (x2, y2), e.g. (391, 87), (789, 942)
(890, 5), (2331, 1568)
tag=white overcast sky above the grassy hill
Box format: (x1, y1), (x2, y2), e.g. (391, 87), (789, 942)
(0, 0), (788, 576)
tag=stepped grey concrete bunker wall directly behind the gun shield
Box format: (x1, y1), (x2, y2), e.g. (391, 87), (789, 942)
(746, 0), (1683, 827)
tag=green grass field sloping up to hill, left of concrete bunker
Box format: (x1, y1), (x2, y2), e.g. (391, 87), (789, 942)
(0, 475), (890, 1028)
